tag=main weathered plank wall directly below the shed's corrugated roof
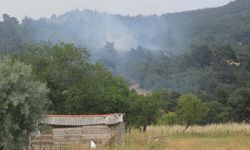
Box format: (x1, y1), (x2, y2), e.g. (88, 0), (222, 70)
(53, 123), (125, 145)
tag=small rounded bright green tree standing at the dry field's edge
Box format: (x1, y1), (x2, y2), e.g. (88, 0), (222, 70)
(177, 94), (208, 131)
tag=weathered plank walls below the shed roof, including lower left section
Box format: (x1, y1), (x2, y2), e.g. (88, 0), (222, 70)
(32, 123), (125, 150)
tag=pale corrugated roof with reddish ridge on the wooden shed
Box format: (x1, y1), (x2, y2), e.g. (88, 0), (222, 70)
(40, 113), (124, 126)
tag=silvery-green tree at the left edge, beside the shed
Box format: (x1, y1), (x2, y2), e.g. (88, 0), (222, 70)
(0, 56), (48, 149)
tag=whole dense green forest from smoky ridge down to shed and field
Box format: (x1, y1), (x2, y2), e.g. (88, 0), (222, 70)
(0, 0), (250, 149)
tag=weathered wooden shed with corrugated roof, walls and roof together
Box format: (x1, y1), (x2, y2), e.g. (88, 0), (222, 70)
(31, 113), (125, 150)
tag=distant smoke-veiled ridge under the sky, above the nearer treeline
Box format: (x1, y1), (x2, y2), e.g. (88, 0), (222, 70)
(20, 0), (250, 50)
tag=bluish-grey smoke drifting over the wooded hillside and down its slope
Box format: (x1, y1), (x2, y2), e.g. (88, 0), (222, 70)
(18, 10), (197, 92)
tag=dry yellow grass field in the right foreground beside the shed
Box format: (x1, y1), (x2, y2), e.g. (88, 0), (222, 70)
(54, 123), (250, 150)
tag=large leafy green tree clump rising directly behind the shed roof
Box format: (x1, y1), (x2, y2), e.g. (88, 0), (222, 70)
(17, 43), (129, 114)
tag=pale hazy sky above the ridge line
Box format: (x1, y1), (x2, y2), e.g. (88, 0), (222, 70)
(0, 0), (232, 19)
